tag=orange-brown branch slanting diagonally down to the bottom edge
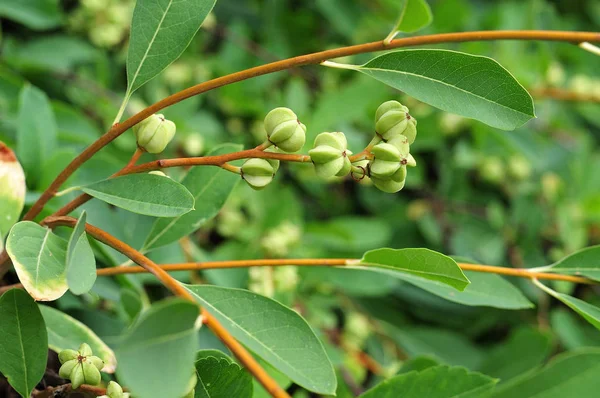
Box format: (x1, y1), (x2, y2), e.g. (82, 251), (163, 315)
(46, 217), (289, 398)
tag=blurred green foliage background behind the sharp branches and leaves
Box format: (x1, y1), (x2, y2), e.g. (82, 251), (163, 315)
(0, 0), (600, 392)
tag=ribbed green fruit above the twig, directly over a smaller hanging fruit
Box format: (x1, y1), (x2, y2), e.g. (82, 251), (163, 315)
(265, 108), (306, 152)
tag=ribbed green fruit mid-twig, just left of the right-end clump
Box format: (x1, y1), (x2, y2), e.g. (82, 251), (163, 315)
(308, 132), (352, 178)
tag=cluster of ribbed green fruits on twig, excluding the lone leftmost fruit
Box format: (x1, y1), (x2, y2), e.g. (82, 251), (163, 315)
(240, 101), (417, 193)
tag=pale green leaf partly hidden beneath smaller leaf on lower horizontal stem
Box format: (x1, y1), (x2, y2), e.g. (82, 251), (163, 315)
(394, 271), (534, 310)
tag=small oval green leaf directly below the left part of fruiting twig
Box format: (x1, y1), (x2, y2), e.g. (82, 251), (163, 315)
(81, 174), (194, 217)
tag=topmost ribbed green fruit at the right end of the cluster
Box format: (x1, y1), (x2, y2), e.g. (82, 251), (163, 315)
(375, 101), (417, 144)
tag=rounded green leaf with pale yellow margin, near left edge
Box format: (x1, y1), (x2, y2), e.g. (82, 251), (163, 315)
(6, 221), (68, 301)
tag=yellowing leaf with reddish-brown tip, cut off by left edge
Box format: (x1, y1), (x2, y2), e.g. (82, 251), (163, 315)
(0, 141), (26, 251)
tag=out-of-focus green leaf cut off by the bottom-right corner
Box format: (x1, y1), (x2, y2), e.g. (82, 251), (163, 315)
(493, 349), (600, 398)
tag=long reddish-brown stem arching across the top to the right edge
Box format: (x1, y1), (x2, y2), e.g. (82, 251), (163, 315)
(23, 30), (600, 220)
